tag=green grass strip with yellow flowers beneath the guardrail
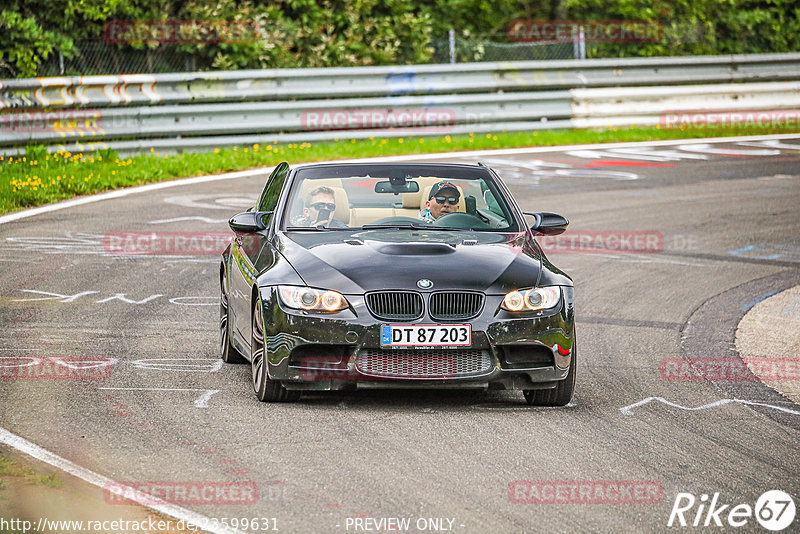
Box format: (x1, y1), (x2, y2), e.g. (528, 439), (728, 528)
(0, 126), (797, 213)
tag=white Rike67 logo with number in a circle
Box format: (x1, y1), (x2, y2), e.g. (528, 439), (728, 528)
(667, 490), (796, 532)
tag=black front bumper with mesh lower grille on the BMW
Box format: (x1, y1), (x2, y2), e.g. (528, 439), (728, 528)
(261, 286), (574, 390)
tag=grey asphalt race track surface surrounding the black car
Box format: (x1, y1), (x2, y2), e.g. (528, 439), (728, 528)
(0, 136), (800, 533)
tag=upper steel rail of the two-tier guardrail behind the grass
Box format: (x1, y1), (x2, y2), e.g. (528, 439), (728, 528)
(0, 53), (800, 109)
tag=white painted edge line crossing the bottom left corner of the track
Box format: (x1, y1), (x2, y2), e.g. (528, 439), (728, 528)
(0, 428), (244, 534)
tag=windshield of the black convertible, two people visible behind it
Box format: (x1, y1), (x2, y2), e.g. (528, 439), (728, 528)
(283, 165), (517, 232)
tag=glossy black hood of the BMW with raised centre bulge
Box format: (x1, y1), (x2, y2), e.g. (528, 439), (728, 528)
(276, 229), (542, 294)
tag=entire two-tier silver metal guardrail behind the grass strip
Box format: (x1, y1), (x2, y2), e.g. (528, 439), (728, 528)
(0, 54), (800, 155)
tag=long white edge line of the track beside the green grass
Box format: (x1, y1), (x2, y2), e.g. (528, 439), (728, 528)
(0, 134), (800, 228)
